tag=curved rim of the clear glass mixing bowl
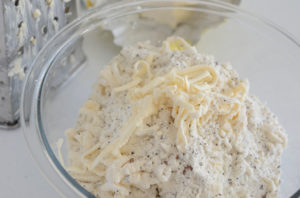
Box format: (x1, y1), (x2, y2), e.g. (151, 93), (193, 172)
(20, 0), (300, 197)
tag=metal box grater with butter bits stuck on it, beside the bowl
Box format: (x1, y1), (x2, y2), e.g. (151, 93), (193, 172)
(0, 0), (85, 128)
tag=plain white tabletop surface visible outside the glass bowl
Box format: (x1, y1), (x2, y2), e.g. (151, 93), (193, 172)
(0, 0), (300, 198)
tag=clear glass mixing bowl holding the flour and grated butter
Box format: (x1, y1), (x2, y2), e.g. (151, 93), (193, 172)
(21, 0), (300, 198)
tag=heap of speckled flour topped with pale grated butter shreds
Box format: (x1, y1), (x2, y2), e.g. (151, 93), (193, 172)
(66, 37), (287, 198)
